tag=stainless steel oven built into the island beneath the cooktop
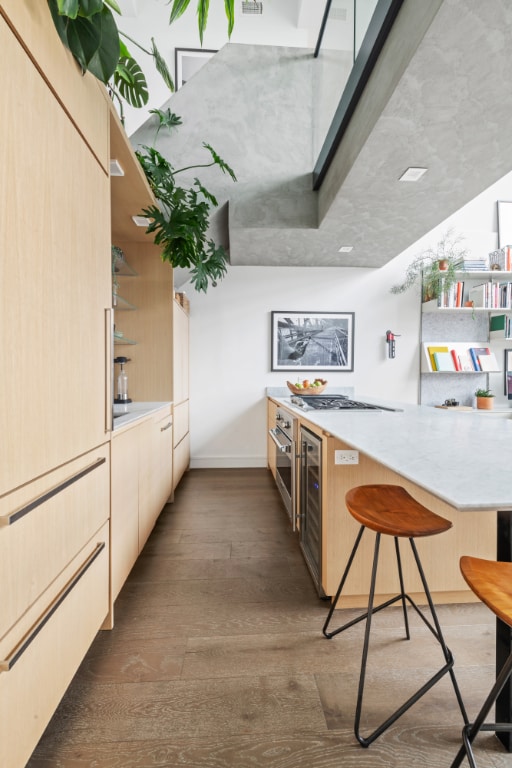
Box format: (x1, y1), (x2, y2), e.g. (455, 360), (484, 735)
(269, 409), (297, 530)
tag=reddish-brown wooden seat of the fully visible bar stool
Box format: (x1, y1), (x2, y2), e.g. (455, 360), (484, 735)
(345, 485), (452, 538)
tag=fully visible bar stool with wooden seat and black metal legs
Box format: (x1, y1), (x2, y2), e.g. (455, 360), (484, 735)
(322, 484), (468, 747)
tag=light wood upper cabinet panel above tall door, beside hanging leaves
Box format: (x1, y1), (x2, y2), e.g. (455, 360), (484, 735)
(0, 0), (110, 171)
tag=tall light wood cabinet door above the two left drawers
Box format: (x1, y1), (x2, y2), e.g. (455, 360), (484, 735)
(0, 19), (110, 494)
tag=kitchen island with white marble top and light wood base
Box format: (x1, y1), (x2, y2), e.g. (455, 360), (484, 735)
(269, 395), (512, 752)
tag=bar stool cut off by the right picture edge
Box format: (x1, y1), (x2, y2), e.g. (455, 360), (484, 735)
(451, 556), (512, 768)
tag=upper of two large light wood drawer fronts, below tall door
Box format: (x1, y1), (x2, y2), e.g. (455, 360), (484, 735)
(0, 445), (110, 640)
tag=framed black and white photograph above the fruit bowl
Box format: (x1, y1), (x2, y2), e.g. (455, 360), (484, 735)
(271, 312), (354, 371)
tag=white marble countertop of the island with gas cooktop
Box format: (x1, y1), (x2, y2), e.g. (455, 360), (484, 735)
(273, 394), (512, 510)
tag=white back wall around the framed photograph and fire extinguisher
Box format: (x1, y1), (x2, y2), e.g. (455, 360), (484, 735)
(184, 174), (512, 467)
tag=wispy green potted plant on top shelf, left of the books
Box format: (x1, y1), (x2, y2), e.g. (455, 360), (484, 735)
(391, 229), (468, 301)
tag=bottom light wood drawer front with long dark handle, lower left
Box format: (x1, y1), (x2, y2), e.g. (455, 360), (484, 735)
(0, 524), (109, 768)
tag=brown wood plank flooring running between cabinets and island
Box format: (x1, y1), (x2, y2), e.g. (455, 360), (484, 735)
(25, 469), (512, 768)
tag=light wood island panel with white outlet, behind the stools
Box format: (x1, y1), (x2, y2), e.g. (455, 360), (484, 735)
(317, 428), (496, 607)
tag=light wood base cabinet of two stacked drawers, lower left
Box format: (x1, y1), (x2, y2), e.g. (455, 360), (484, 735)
(0, 444), (110, 768)
